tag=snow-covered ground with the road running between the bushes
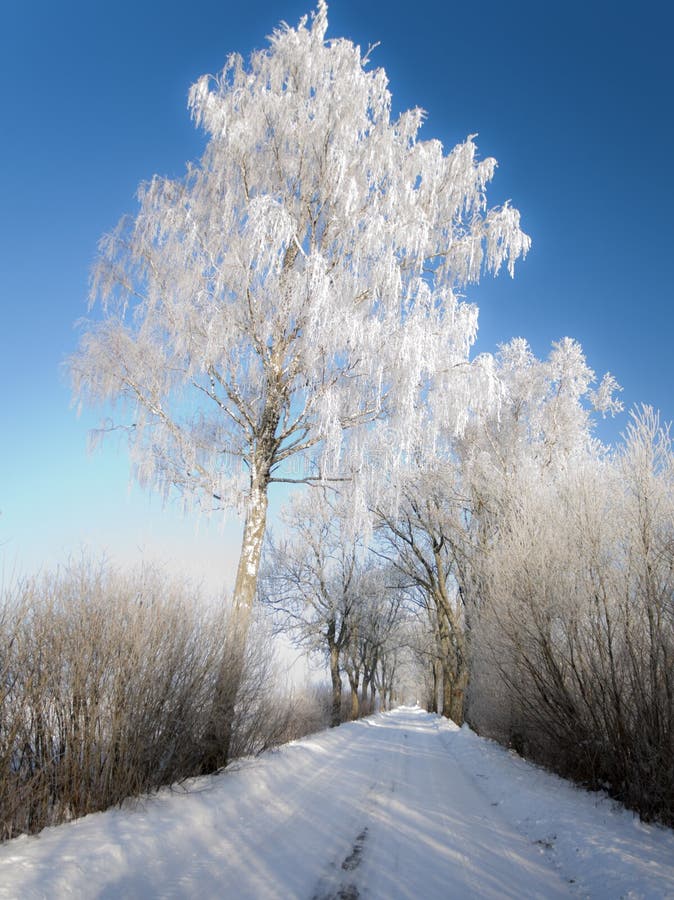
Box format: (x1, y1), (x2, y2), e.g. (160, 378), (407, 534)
(0, 708), (674, 900)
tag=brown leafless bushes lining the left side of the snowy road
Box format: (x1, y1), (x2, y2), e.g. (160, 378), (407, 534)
(0, 563), (296, 838)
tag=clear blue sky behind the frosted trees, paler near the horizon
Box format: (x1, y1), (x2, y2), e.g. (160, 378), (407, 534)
(0, 0), (674, 584)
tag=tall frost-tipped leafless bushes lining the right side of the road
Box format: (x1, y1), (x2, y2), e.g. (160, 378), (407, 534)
(471, 410), (674, 824)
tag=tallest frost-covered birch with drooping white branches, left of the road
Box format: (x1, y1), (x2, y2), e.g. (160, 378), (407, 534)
(71, 0), (529, 648)
